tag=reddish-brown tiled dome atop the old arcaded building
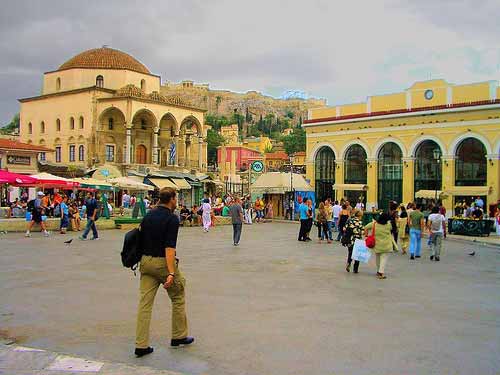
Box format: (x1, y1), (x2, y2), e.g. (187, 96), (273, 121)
(58, 47), (151, 74)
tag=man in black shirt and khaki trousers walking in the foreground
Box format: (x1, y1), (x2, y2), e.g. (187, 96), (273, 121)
(135, 188), (194, 357)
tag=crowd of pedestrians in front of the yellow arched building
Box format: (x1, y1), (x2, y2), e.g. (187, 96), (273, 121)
(298, 199), (452, 279)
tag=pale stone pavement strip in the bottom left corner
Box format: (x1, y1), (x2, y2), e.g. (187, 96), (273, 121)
(0, 340), (181, 375)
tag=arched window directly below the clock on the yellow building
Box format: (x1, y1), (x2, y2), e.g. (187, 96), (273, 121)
(414, 140), (442, 193)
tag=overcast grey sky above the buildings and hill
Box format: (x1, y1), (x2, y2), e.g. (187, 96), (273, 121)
(0, 0), (500, 124)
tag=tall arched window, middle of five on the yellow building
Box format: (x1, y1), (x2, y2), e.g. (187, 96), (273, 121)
(378, 142), (403, 209)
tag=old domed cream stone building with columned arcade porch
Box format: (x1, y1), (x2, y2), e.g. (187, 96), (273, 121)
(19, 47), (207, 172)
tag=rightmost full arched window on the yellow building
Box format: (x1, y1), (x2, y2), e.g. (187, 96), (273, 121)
(455, 138), (487, 186)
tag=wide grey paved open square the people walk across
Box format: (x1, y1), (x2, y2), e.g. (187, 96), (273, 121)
(0, 223), (500, 375)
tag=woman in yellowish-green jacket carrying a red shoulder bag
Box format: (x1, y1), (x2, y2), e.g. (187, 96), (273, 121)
(365, 212), (397, 279)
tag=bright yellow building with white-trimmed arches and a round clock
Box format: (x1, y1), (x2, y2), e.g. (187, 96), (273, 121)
(303, 80), (500, 213)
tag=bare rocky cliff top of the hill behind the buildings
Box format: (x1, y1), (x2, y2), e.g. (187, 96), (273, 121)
(160, 81), (326, 119)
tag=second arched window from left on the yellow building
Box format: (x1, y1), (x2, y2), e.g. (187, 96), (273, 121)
(344, 145), (367, 205)
